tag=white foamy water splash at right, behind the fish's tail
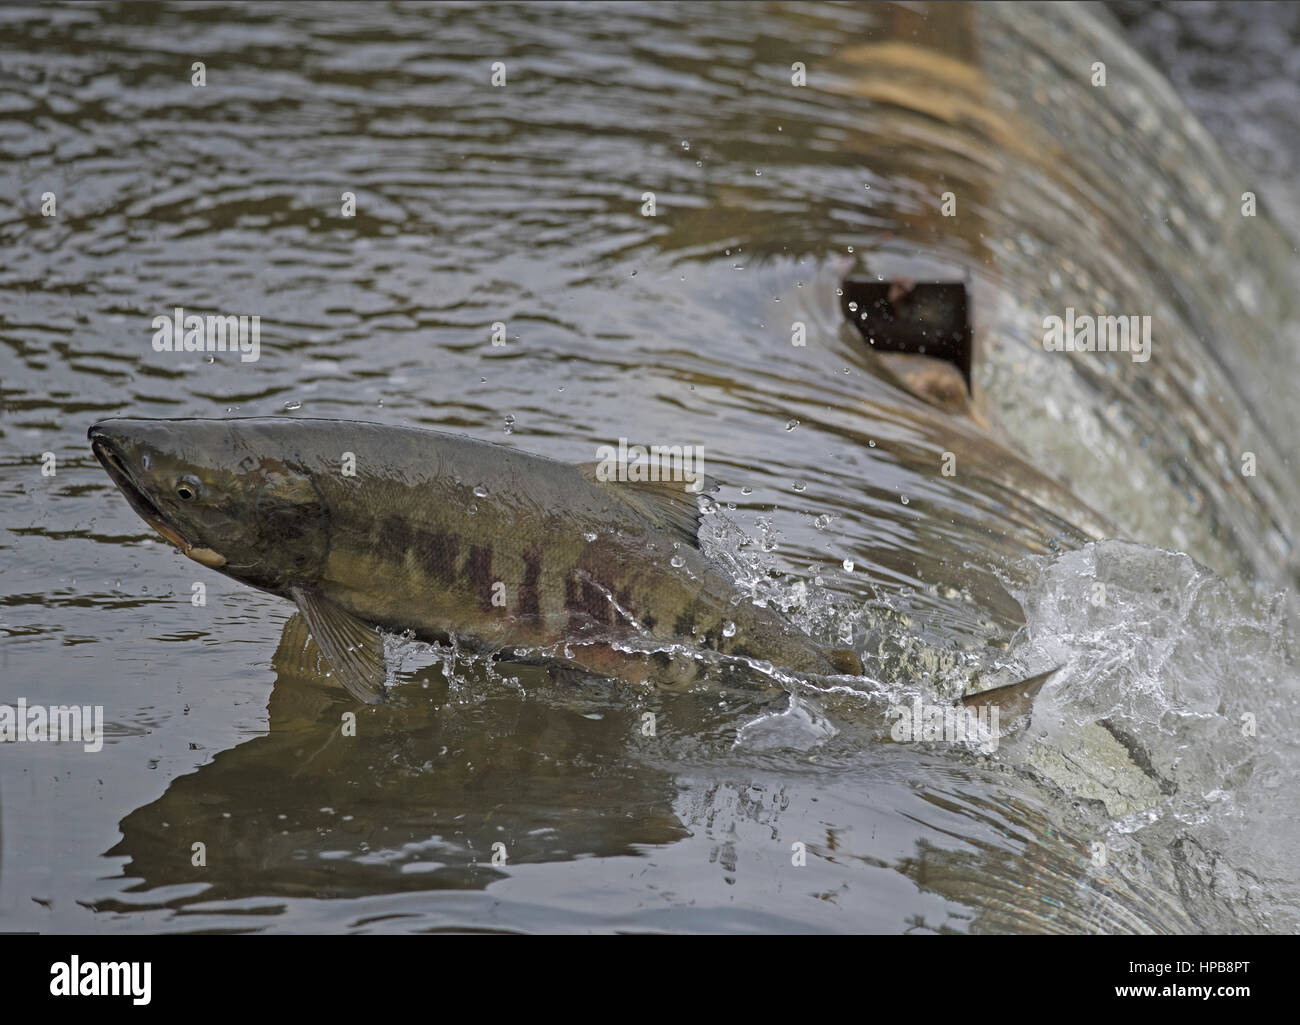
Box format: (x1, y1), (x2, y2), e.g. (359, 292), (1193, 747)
(1002, 541), (1300, 930)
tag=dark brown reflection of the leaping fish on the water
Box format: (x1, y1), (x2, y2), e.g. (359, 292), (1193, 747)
(109, 614), (684, 900)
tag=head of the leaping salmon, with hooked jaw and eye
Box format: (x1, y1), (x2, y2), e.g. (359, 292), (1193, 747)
(88, 419), (329, 593)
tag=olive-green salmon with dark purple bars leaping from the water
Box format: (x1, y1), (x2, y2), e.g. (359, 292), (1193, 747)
(90, 419), (861, 701)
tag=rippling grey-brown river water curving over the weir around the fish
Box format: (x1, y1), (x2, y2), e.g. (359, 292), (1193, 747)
(0, 3), (1300, 931)
